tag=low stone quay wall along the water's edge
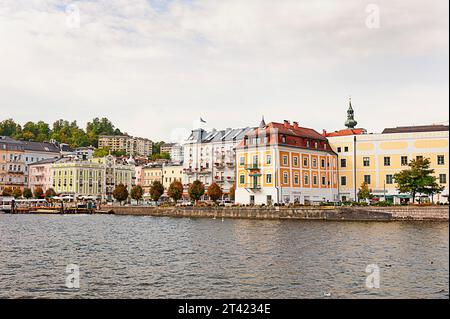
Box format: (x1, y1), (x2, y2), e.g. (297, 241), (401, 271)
(109, 206), (449, 222)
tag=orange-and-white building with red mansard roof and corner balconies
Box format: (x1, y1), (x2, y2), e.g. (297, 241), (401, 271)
(235, 121), (338, 204)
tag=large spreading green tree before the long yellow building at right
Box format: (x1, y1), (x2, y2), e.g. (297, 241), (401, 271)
(394, 158), (444, 203)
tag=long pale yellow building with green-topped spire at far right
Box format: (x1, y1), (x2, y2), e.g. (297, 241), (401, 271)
(324, 101), (449, 202)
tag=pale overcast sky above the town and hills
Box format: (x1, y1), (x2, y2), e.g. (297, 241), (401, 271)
(0, 0), (449, 140)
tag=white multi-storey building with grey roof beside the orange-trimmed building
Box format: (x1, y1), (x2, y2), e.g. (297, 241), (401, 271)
(183, 127), (253, 194)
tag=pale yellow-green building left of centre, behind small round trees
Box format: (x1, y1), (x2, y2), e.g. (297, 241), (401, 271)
(50, 155), (134, 201)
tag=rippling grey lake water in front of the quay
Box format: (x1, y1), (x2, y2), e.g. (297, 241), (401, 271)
(0, 215), (449, 298)
